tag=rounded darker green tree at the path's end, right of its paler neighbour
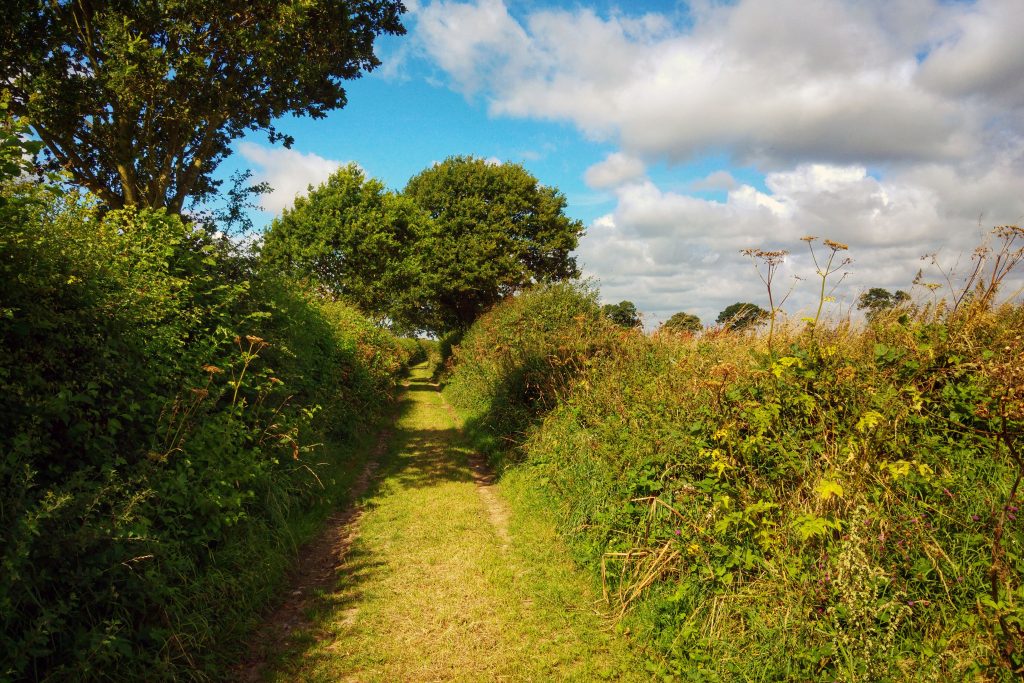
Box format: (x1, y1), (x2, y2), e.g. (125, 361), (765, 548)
(404, 157), (584, 332)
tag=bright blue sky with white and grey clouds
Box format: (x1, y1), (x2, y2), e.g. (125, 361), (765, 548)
(230, 0), (1024, 327)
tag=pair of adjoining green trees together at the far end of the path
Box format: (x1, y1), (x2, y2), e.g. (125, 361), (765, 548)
(263, 157), (583, 336)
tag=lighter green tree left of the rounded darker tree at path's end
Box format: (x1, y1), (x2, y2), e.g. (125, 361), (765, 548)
(261, 164), (430, 328)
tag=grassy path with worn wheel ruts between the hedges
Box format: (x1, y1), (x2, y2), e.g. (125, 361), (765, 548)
(240, 369), (647, 682)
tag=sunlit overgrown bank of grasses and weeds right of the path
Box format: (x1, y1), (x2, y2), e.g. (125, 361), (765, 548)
(447, 237), (1024, 681)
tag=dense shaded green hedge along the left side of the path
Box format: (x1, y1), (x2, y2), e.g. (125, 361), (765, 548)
(0, 176), (406, 680)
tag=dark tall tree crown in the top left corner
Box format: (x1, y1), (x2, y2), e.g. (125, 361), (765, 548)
(0, 0), (404, 212)
